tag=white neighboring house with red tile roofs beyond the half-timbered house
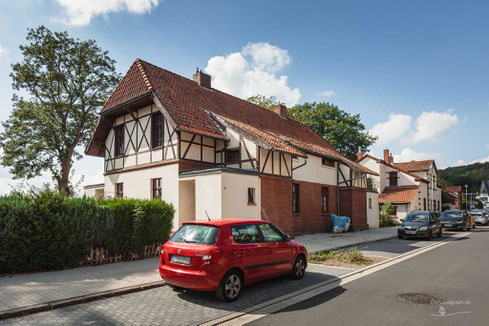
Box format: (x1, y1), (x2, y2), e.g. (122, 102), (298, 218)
(357, 149), (442, 219)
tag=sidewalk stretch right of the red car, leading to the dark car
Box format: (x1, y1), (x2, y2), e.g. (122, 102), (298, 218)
(295, 227), (397, 252)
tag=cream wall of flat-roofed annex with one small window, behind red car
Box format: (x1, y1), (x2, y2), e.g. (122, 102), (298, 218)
(222, 173), (261, 220)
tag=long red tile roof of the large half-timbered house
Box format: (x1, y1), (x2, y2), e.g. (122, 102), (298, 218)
(89, 59), (376, 174)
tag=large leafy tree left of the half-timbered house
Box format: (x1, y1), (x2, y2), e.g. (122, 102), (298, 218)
(0, 26), (120, 195)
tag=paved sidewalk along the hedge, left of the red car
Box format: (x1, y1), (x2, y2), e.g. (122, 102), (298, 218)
(0, 258), (161, 313)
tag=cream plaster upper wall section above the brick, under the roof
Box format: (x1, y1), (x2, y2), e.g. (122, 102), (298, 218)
(292, 155), (338, 186)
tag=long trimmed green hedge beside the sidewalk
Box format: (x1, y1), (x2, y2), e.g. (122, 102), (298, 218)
(0, 189), (175, 273)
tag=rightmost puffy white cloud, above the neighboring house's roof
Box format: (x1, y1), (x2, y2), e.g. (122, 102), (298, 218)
(409, 110), (459, 143)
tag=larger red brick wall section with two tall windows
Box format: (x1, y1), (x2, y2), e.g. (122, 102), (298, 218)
(260, 175), (337, 236)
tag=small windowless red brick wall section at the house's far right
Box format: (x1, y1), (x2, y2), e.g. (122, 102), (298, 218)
(340, 188), (368, 231)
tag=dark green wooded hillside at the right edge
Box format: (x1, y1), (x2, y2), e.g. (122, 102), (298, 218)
(439, 162), (489, 192)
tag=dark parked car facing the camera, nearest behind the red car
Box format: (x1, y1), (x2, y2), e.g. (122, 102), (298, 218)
(397, 211), (443, 240)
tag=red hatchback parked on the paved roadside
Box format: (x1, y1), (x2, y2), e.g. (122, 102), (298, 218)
(159, 219), (307, 302)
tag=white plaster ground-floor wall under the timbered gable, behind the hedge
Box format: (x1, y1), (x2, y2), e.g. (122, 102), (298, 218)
(104, 164), (179, 229)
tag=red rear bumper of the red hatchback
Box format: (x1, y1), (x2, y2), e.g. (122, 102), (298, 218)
(159, 264), (220, 291)
